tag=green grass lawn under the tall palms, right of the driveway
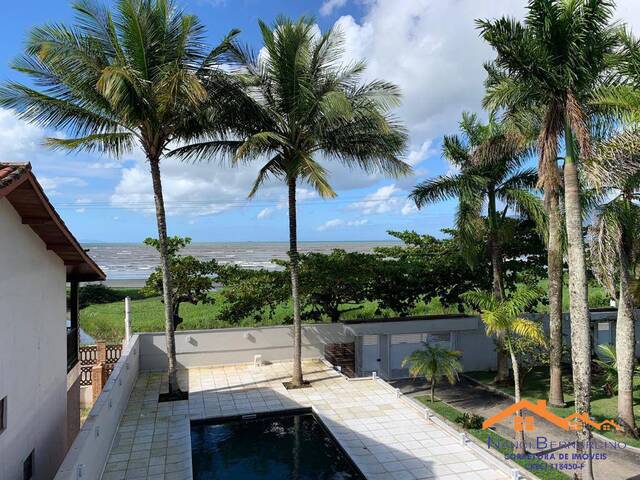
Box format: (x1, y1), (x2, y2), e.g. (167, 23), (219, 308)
(466, 368), (640, 447)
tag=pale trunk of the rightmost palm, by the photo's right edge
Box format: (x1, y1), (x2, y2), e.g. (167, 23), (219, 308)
(616, 245), (636, 433)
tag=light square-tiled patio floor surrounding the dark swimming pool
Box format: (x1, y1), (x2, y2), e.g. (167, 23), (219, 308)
(102, 361), (507, 480)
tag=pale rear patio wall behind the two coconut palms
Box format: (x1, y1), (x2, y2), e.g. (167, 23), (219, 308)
(139, 324), (353, 371)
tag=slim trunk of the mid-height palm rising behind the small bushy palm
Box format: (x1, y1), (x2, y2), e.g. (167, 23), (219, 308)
(487, 188), (509, 383)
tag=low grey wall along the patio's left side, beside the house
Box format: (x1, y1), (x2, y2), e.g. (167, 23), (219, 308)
(54, 335), (140, 480)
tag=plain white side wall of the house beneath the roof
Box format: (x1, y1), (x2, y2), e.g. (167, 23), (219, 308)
(0, 198), (67, 480)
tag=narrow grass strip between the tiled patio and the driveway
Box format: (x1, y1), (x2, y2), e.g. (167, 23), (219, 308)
(416, 396), (571, 480)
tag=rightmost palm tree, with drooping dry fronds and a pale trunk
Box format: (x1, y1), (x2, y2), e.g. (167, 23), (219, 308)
(589, 144), (640, 433)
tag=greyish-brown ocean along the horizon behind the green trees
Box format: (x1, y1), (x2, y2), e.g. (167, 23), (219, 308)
(84, 241), (397, 284)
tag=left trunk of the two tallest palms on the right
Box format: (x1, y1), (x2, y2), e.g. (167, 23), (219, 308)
(545, 189), (565, 407)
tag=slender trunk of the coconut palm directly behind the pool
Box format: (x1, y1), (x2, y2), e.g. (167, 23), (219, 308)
(288, 176), (303, 387)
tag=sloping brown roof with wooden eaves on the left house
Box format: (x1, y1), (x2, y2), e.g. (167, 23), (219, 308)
(0, 162), (106, 282)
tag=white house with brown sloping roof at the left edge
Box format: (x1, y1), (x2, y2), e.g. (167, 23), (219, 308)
(0, 163), (105, 480)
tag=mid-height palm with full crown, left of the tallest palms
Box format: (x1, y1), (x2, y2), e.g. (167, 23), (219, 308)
(411, 113), (544, 382)
